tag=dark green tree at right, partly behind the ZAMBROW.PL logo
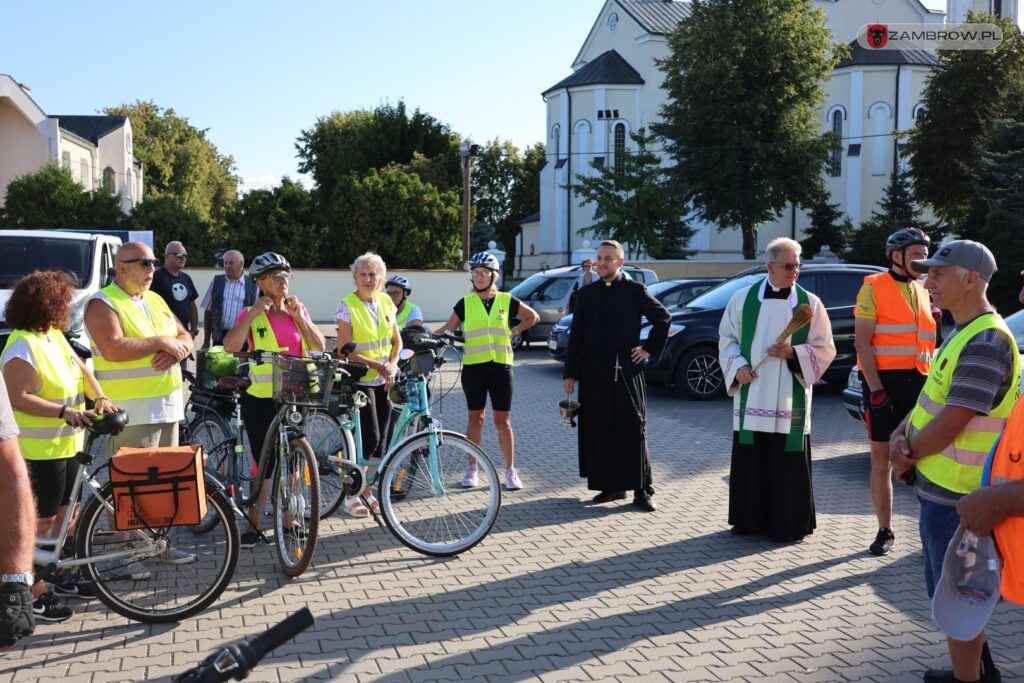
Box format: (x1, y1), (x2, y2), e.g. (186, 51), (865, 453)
(907, 13), (1024, 231)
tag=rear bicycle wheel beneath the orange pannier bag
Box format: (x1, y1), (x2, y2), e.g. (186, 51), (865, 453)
(75, 484), (240, 624)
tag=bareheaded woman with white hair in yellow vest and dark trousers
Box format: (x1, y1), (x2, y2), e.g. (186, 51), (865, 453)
(334, 252), (401, 517)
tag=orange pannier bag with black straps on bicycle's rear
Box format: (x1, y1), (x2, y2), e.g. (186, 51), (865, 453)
(111, 443), (206, 531)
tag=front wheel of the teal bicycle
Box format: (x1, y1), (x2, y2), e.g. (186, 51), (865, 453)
(378, 431), (502, 557)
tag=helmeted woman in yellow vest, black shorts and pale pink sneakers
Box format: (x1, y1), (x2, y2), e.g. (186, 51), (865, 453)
(437, 252), (541, 490)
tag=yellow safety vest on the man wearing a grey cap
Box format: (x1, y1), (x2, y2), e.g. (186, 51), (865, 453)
(908, 313), (1021, 494)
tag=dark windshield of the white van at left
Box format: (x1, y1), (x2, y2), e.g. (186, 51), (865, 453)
(0, 237), (93, 289)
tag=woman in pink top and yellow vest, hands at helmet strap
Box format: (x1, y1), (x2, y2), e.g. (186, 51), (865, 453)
(224, 252), (324, 548)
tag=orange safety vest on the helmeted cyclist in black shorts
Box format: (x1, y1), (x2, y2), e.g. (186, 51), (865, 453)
(857, 272), (936, 375)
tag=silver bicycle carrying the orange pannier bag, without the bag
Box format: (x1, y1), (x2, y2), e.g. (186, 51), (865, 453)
(33, 412), (241, 624)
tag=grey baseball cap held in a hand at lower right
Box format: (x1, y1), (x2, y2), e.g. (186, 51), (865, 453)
(932, 526), (1002, 640)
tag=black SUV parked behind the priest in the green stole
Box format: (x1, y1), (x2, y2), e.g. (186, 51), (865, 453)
(641, 263), (885, 400)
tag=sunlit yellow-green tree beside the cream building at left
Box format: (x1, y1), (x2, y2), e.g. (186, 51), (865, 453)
(103, 100), (239, 227)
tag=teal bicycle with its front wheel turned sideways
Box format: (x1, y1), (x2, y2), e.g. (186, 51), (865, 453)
(306, 334), (502, 557)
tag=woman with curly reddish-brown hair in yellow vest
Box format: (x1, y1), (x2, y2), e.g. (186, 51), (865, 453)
(3, 270), (116, 622)
